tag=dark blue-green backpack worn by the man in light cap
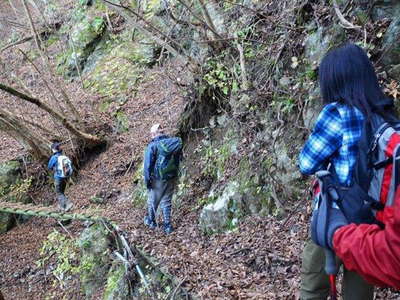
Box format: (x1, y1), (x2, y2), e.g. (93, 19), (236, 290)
(156, 137), (182, 180)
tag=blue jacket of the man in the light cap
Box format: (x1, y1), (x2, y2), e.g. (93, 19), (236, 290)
(143, 135), (182, 185)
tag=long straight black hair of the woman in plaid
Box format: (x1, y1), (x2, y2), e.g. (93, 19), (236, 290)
(318, 44), (393, 119)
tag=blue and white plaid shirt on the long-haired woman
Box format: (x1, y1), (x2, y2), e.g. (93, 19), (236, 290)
(299, 102), (364, 186)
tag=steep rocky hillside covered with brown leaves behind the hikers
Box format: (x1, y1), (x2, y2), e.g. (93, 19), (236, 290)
(0, 0), (400, 299)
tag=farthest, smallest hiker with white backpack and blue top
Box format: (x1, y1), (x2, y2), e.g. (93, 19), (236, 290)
(47, 143), (73, 211)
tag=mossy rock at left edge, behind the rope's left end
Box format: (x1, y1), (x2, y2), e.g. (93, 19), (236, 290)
(0, 160), (30, 233)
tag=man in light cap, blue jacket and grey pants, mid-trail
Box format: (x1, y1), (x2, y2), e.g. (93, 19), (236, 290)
(144, 124), (182, 234)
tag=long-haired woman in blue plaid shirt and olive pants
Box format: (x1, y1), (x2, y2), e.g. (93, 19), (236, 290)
(299, 44), (393, 300)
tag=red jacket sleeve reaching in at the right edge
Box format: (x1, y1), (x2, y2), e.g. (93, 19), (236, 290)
(333, 203), (400, 289)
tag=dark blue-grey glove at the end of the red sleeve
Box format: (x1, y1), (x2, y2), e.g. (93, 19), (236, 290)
(311, 197), (349, 249)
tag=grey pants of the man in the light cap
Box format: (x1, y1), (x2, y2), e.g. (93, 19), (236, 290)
(147, 178), (176, 224)
